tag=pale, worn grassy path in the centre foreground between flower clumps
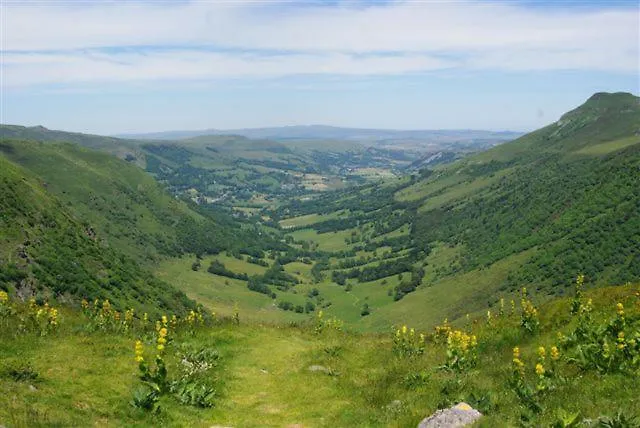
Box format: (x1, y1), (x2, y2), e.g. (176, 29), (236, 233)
(210, 327), (349, 427)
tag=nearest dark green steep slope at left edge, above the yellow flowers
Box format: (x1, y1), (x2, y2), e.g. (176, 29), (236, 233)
(0, 152), (194, 314)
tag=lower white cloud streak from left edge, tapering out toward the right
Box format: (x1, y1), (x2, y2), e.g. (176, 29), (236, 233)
(4, 50), (451, 86)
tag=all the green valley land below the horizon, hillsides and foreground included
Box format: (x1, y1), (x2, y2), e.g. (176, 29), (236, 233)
(0, 93), (640, 427)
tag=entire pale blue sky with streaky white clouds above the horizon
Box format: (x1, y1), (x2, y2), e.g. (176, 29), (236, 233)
(0, 0), (640, 134)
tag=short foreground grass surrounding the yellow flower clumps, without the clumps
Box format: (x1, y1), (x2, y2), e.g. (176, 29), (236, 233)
(0, 285), (640, 427)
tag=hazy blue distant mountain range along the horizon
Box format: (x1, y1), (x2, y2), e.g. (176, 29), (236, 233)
(118, 125), (523, 143)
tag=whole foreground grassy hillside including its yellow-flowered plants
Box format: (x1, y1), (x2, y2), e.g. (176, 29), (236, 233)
(0, 285), (640, 427)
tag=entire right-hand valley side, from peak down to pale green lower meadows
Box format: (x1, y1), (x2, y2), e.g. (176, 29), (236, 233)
(252, 94), (640, 330)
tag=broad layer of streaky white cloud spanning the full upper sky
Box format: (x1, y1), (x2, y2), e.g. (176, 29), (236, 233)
(1, 1), (639, 86)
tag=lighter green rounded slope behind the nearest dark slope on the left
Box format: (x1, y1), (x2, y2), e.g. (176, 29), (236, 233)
(2, 140), (245, 261)
